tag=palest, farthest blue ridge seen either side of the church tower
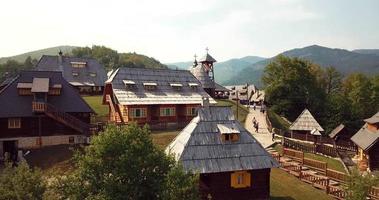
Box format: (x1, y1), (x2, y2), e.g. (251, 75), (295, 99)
(166, 56), (265, 83)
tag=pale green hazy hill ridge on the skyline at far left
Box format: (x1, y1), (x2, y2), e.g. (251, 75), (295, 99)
(0, 46), (76, 64)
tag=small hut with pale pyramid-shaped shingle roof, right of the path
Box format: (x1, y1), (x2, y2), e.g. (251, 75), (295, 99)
(289, 109), (324, 140)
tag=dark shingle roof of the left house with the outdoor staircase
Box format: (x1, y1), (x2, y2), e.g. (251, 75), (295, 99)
(0, 71), (93, 117)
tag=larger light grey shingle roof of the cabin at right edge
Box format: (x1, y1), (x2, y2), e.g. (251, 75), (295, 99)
(351, 123), (379, 151)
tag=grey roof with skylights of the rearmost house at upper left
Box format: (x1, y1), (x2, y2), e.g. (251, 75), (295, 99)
(36, 55), (107, 86)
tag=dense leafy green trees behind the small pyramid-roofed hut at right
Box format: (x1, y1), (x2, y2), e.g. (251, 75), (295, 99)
(262, 56), (379, 133)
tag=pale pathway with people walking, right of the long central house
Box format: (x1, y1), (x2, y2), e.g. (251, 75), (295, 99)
(245, 107), (274, 148)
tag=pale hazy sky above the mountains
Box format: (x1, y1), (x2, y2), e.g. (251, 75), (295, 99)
(0, 0), (379, 62)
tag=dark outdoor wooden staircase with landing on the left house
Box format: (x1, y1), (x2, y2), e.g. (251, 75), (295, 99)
(32, 102), (94, 135)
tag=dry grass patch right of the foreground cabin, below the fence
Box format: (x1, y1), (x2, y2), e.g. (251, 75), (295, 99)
(270, 168), (333, 200)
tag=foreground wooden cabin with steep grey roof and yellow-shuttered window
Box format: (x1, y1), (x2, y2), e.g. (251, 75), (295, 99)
(166, 103), (278, 200)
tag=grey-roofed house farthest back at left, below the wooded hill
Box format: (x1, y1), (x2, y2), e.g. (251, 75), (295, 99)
(36, 52), (107, 95)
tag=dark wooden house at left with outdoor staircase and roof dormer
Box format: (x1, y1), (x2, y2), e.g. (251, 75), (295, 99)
(0, 71), (93, 162)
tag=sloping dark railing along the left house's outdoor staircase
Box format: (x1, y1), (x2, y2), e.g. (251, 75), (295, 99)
(45, 104), (93, 134)
